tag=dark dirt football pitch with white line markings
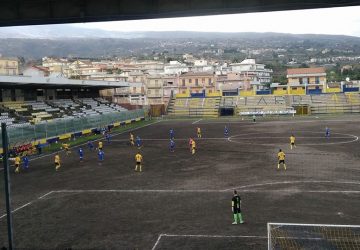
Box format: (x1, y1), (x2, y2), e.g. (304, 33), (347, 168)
(0, 116), (360, 250)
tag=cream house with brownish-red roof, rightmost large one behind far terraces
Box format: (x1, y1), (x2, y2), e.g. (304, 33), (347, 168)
(286, 67), (326, 94)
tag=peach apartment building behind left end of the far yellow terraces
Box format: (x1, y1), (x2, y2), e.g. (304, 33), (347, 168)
(179, 72), (216, 94)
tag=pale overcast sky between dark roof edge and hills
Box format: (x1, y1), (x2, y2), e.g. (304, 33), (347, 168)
(74, 6), (360, 37)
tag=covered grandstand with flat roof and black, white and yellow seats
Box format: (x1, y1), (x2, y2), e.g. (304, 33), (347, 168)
(0, 76), (145, 151)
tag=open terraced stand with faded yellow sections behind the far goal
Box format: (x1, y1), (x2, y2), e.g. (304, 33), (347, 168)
(168, 92), (360, 117)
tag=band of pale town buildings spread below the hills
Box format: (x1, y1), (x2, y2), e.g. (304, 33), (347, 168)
(0, 54), (360, 108)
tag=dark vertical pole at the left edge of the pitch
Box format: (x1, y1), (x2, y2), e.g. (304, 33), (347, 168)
(1, 123), (14, 250)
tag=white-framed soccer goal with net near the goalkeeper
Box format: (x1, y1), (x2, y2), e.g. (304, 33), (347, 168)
(267, 223), (360, 250)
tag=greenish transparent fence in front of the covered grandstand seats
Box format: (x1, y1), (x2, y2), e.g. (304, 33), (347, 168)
(0, 109), (146, 146)
